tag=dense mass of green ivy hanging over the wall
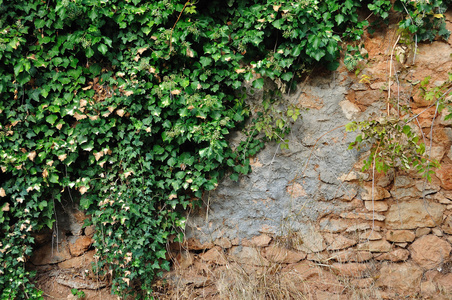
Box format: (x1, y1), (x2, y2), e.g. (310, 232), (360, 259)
(0, 0), (448, 299)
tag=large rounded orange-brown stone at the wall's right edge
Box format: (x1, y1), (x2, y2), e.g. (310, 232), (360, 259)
(409, 235), (452, 269)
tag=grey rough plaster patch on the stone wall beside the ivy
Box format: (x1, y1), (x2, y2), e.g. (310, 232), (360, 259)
(186, 73), (356, 244)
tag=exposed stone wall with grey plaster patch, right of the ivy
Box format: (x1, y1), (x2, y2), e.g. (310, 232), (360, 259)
(162, 13), (452, 299)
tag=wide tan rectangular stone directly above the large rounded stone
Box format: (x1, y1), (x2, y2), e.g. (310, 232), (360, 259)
(386, 199), (444, 229)
